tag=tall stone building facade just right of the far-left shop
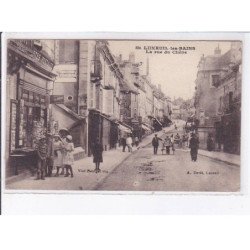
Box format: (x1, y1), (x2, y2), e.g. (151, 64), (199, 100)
(54, 40), (123, 155)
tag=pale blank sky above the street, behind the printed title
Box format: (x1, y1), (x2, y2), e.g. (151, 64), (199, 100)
(109, 40), (231, 99)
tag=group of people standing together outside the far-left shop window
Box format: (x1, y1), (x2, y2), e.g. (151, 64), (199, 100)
(36, 133), (74, 180)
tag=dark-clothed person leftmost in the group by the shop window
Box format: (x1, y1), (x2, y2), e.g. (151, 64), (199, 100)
(36, 135), (47, 180)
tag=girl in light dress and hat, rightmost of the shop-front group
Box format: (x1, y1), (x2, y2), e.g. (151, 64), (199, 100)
(63, 135), (74, 177)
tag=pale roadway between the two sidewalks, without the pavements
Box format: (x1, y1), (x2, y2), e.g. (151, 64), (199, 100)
(96, 131), (240, 192)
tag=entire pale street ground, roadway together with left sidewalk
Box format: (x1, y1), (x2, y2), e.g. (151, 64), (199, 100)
(7, 124), (240, 192)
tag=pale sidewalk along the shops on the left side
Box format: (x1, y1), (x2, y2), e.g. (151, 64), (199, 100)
(6, 126), (173, 190)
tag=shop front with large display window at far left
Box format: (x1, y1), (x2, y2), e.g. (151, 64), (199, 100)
(6, 39), (55, 177)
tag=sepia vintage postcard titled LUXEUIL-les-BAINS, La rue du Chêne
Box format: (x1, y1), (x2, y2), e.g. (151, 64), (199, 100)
(2, 36), (244, 192)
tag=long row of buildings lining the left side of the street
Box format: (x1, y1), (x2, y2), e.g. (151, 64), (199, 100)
(6, 40), (172, 176)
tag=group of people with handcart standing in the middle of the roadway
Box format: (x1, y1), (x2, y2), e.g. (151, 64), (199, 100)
(152, 133), (199, 161)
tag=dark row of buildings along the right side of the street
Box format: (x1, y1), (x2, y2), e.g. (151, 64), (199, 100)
(195, 41), (242, 154)
